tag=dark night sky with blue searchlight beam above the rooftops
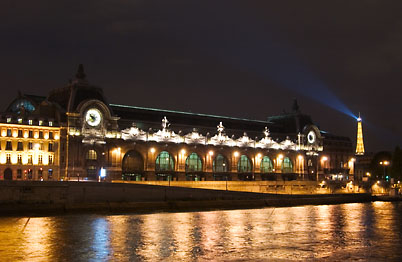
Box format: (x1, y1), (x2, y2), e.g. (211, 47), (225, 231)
(0, 0), (402, 151)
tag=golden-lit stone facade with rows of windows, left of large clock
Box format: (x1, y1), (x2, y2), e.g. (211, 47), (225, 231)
(0, 123), (60, 180)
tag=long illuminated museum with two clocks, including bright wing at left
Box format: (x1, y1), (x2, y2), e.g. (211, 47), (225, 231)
(0, 65), (354, 181)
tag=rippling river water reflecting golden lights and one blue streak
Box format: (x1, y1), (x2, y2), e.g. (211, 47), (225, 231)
(0, 202), (402, 261)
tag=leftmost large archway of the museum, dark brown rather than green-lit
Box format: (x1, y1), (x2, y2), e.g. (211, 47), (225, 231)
(122, 150), (144, 181)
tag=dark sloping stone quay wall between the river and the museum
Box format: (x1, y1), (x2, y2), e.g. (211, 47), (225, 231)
(0, 181), (388, 216)
